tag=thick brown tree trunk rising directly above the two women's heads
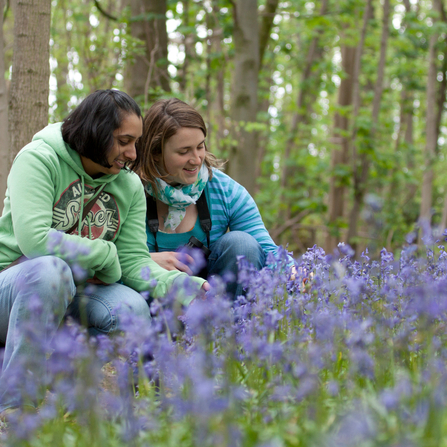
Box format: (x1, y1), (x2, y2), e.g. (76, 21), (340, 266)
(124, 0), (171, 109)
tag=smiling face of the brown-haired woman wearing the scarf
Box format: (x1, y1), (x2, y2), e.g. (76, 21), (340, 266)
(155, 127), (205, 186)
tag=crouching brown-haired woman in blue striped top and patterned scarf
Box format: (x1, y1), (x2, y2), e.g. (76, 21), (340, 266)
(133, 98), (294, 297)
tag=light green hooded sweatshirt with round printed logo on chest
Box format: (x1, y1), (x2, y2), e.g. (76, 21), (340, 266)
(0, 123), (204, 298)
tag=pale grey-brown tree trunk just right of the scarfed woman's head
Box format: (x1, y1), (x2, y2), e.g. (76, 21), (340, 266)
(228, 0), (259, 194)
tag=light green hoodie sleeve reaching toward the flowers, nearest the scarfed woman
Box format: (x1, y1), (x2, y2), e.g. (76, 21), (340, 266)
(115, 180), (205, 298)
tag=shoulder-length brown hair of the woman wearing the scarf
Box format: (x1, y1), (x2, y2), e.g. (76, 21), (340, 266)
(130, 98), (223, 191)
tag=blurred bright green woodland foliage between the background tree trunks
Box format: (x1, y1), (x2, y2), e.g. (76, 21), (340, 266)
(43, 0), (447, 260)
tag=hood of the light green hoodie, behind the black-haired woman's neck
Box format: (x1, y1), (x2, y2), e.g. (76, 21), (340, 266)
(33, 123), (119, 185)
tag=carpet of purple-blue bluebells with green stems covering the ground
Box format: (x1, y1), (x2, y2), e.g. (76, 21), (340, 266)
(0, 236), (447, 447)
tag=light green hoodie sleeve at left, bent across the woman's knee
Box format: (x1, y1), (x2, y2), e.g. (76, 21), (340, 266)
(8, 143), (121, 283)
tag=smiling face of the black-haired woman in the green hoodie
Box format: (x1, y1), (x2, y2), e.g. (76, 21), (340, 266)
(81, 114), (143, 177)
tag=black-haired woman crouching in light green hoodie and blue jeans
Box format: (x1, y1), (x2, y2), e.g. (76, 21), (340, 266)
(0, 90), (209, 412)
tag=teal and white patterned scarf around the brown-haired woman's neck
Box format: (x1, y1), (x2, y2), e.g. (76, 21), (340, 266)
(146, 163), (208, 231)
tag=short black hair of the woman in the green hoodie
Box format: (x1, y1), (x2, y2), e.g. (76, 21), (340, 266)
(62, 90), (141, 168)
